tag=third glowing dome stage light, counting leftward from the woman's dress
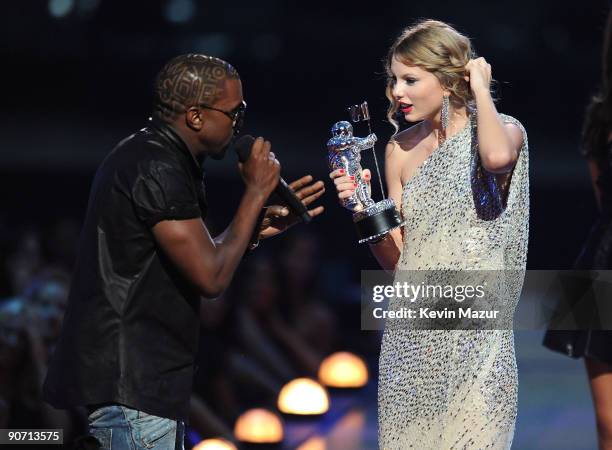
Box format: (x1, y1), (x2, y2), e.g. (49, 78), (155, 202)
(234, 408), (283, 444)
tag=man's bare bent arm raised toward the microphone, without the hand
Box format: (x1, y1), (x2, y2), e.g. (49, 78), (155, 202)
(153, 188), (266, 298)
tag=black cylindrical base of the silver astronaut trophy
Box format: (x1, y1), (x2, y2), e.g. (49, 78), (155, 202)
(353, 199), (403, 244)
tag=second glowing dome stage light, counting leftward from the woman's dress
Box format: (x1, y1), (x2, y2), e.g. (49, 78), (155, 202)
(278, 378), (329, 416)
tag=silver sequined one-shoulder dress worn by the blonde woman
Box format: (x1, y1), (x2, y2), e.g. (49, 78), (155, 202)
(378, 115), (529, 450)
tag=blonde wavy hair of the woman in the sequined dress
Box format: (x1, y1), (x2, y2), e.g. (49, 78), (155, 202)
(385, 20), (476, 131)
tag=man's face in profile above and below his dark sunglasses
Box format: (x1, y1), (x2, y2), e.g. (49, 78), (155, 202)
(200, 79), (243, 159)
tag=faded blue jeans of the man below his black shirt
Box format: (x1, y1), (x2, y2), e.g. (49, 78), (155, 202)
(88, 405), (185, 450)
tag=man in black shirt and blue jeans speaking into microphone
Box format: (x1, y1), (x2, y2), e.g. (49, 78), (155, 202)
(44, 54), (324, 449)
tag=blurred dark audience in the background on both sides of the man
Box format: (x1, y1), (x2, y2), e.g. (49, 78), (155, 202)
(0, 219), (364, 445)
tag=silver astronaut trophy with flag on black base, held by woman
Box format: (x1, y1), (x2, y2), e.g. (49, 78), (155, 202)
(327, 102), (403, 244)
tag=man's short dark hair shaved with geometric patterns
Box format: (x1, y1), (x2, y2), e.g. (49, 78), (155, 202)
(153, 53), (240, 122)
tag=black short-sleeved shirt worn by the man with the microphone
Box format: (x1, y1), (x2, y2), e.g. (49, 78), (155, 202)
(44, 118), (206, 420)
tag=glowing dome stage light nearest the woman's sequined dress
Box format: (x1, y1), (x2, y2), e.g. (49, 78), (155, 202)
(319, 352), (368, 388)
